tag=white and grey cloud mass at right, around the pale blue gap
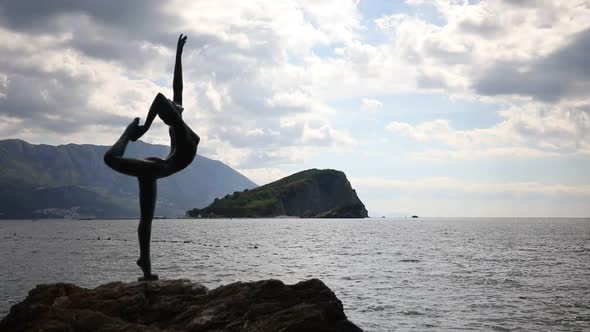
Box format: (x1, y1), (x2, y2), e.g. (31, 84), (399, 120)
(376, 0), (590, 160)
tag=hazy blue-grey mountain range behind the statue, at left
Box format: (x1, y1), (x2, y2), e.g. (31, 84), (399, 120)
(0, 139), (256, 218)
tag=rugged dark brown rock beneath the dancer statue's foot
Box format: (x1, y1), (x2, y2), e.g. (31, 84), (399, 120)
(0, 279), (361, 332)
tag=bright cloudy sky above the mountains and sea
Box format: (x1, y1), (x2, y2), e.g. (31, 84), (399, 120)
(0, 0), (590, 217)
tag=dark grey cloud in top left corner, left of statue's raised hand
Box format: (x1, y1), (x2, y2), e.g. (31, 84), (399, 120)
(0, 0), (181, 66)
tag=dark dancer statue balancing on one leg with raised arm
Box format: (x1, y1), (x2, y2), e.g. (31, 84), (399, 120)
(104, 34), (200, 281)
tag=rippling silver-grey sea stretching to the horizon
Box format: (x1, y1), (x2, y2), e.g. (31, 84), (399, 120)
(0, 218), (590, 331)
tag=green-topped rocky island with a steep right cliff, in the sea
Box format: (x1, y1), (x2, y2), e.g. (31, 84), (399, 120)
(187, 169), (367, 218)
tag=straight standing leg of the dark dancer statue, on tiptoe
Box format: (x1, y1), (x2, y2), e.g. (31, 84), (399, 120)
(137, 177), (158, 280)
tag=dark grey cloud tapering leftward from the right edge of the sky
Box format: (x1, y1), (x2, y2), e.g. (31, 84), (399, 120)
(473, 29), (590, 102)
